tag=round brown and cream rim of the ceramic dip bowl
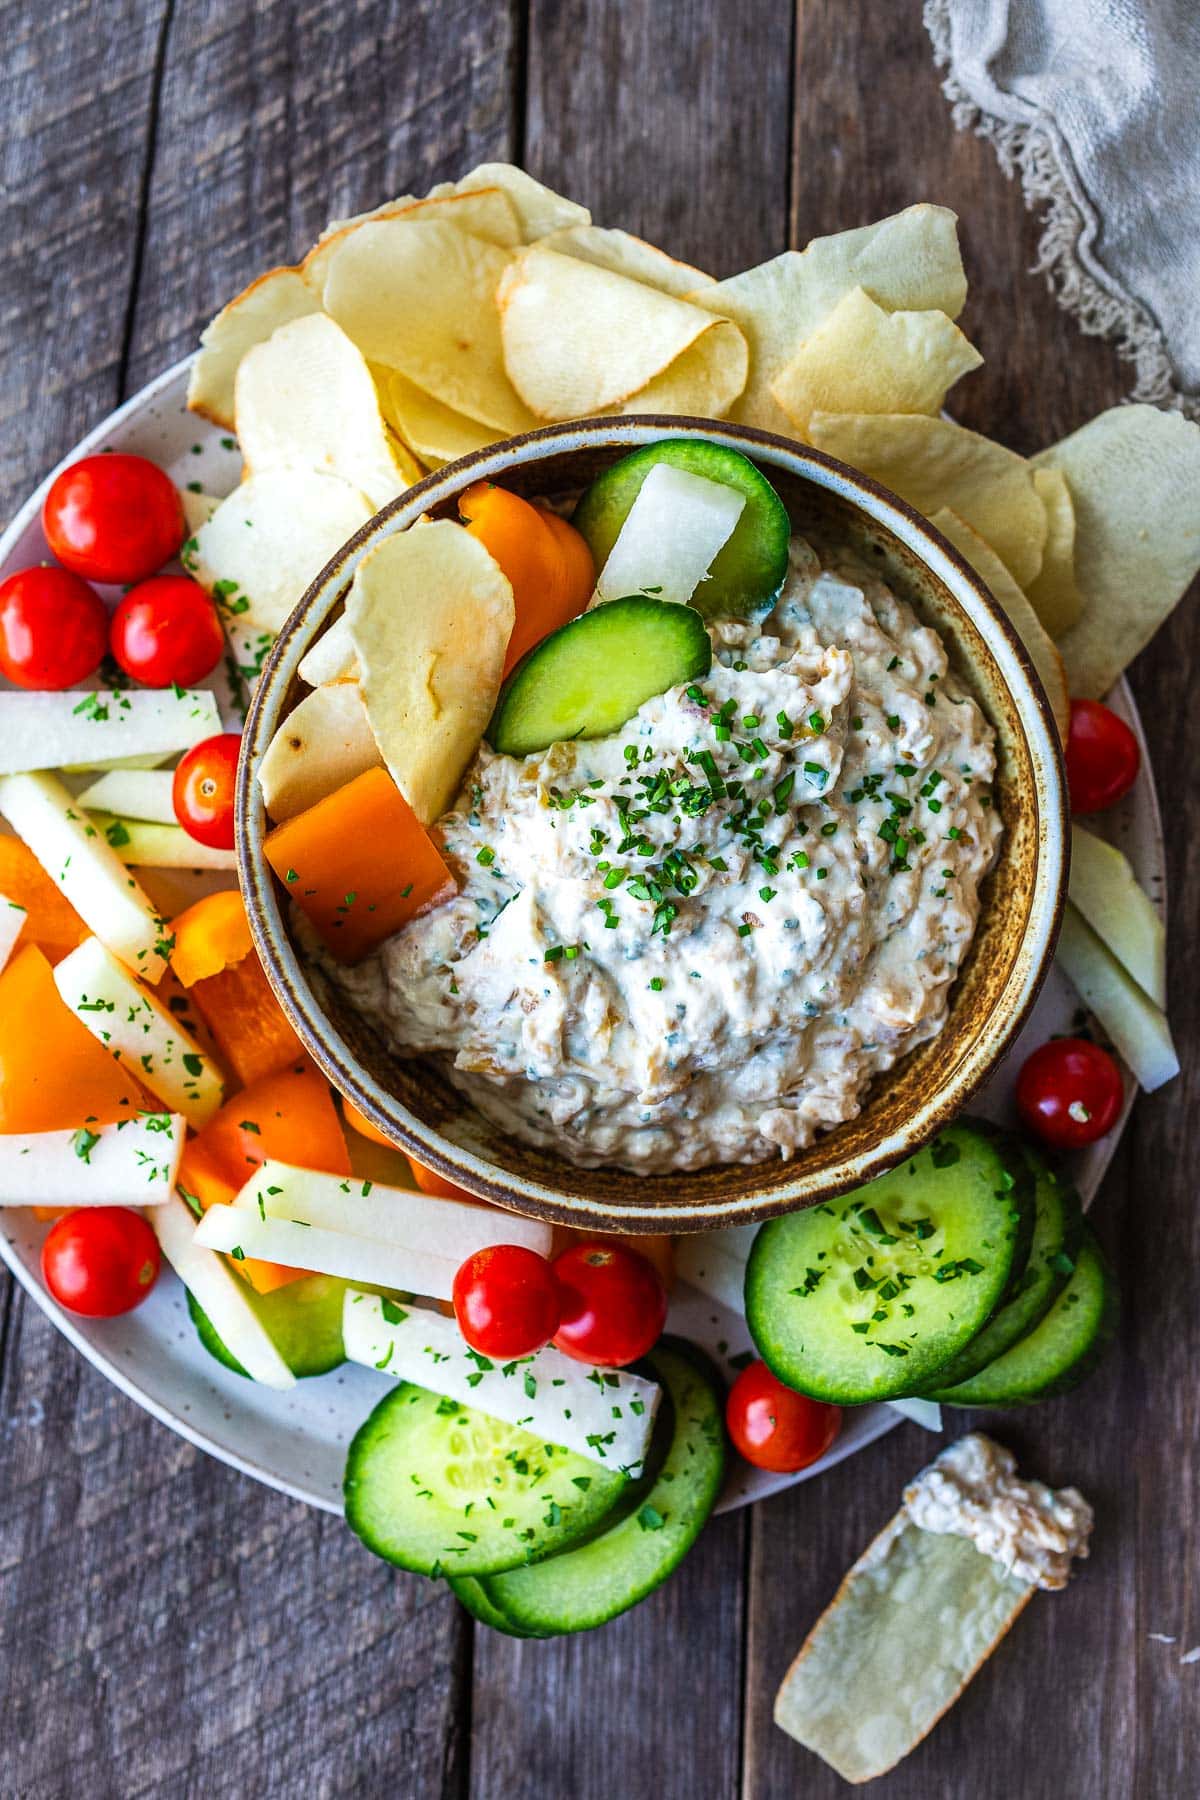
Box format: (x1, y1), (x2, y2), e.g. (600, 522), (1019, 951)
(236, 414), (1069, 1233)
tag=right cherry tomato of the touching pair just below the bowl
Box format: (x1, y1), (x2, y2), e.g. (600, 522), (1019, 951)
(554, 1242), (667, 1368)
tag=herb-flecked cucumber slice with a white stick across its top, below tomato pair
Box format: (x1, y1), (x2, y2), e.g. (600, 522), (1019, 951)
(345, 1381), (628, 1575)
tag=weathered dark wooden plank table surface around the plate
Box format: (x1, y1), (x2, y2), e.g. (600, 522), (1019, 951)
(0, 0), (1200, 1800)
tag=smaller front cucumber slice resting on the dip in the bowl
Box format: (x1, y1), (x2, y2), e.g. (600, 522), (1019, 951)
(488, 598), (712, 756)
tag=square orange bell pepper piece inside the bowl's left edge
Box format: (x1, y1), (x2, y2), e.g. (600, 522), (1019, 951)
(263, 769), (453, 963)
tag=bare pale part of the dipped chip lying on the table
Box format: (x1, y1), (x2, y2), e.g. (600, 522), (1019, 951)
(775, 1507), (1036, 1782)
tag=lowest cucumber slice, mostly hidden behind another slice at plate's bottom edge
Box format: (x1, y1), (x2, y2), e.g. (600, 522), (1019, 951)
(480, 1339), (725, 1636)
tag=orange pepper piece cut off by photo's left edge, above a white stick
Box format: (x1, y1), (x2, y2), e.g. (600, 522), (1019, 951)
(0, 943), (150, 1132)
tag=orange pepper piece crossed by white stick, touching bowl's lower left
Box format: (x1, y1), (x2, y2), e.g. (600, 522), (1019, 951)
(178, 1062), (351, 1294)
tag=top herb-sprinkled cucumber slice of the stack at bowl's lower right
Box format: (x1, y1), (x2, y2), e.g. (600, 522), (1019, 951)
(745, 1120), (1033, 1406)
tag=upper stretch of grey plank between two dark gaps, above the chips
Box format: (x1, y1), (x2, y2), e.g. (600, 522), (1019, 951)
(130, 0), (528, 387)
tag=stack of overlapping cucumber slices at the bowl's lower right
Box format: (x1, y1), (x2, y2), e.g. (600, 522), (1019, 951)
(745, 1120), (1117, 1406)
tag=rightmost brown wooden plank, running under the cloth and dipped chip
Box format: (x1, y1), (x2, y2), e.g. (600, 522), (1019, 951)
(743, 5), (1200, 1800)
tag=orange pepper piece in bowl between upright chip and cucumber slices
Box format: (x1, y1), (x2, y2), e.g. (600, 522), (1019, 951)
(459, 481), (596, 675)
